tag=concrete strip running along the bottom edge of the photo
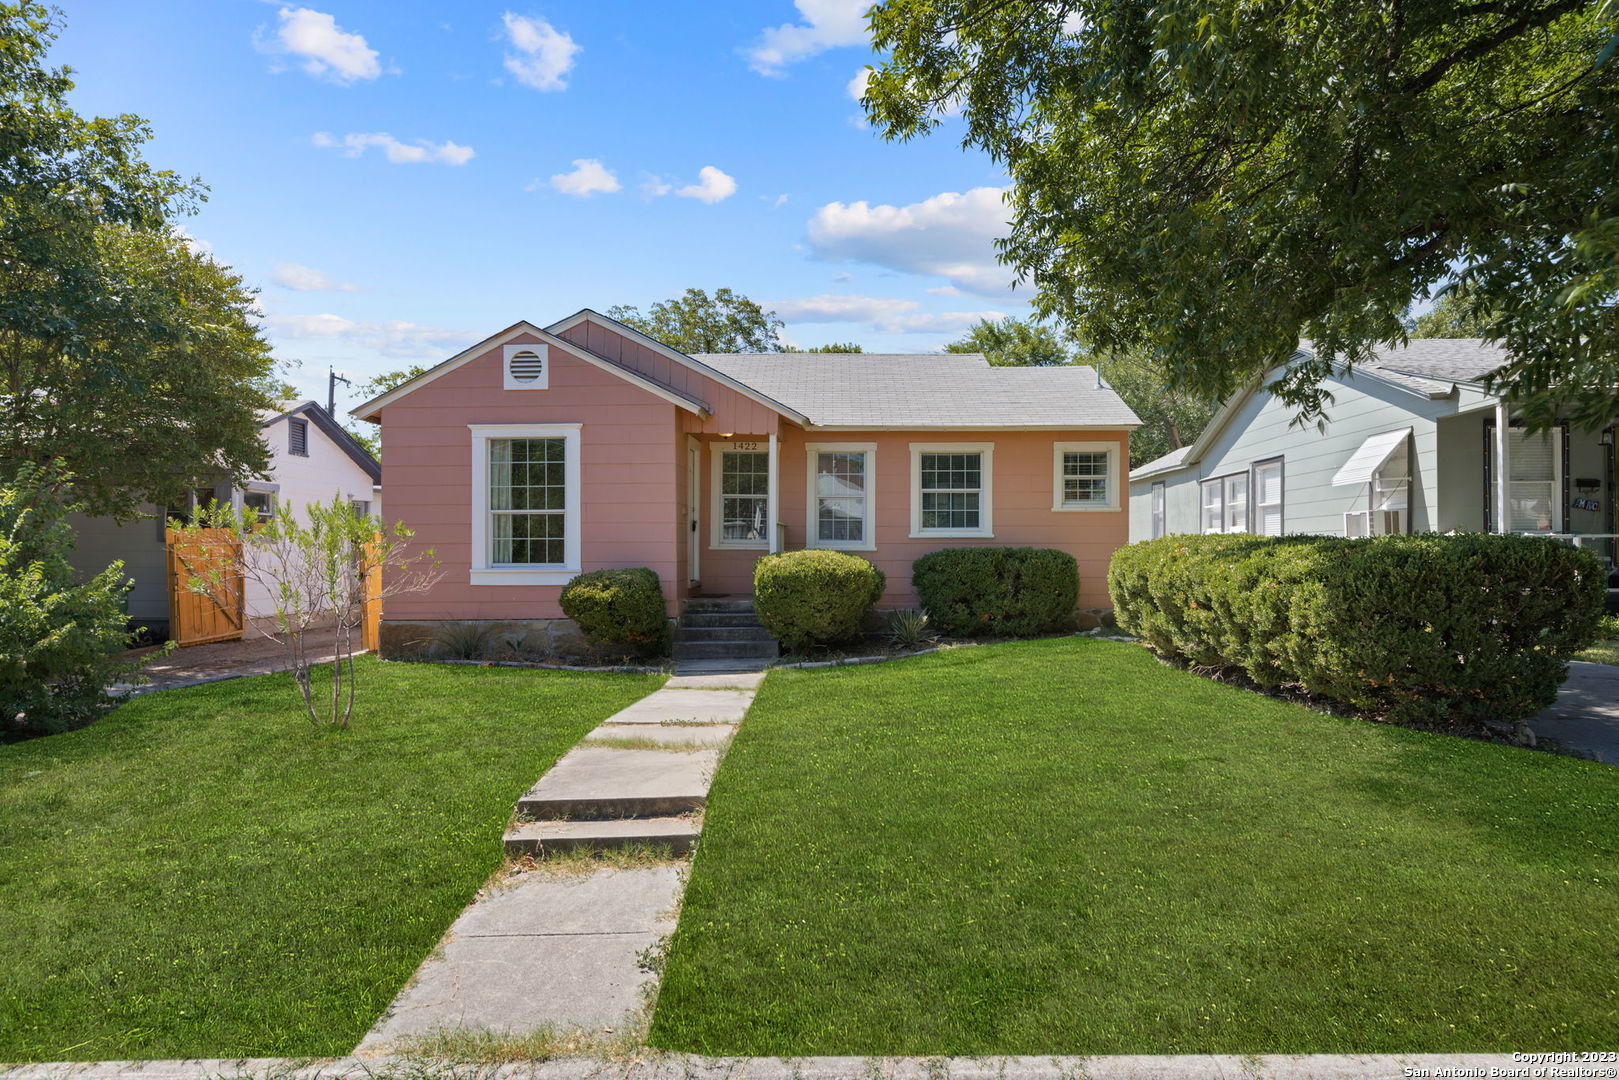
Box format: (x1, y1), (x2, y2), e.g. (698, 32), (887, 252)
(0, 1051), (1541, 1080)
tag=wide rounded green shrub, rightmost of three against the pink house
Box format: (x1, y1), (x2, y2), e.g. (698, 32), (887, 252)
(911, 547), (1080, 638)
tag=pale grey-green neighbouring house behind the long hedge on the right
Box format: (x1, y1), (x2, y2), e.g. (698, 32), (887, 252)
(1130, 338), (1619, 582)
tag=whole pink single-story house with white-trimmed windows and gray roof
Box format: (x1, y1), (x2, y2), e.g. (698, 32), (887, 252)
(355, 309), (1138, 653)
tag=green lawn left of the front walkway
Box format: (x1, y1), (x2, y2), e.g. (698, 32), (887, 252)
(0, 657), (661, 1061)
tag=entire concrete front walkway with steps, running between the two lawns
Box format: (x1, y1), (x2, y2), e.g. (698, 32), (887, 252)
(356, 674), (764, 1057)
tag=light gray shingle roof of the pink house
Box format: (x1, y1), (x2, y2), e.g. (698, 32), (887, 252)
(693, 353), (1141, 427)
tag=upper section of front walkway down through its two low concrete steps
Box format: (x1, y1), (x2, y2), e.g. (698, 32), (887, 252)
(504, 675), (764, 858)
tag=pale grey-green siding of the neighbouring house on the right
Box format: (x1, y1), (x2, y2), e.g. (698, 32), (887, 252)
(1130, 374), (1455, 541)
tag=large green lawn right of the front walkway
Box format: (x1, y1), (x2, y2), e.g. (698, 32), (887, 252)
(651, 638), (1619, 1056)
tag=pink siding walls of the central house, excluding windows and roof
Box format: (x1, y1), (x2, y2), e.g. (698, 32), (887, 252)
(382, 314), (1128, 620)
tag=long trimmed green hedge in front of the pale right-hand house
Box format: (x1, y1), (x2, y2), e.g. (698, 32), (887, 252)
(1107, 534), (1604, 724)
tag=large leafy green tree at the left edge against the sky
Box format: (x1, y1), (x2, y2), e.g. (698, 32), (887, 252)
(0, 0), (275, 517)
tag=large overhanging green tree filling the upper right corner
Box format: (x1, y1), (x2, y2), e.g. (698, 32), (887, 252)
(865, 0), (1619, 424)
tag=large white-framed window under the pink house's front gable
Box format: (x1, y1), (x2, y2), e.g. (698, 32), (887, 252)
(470, 424), (581, 585)
